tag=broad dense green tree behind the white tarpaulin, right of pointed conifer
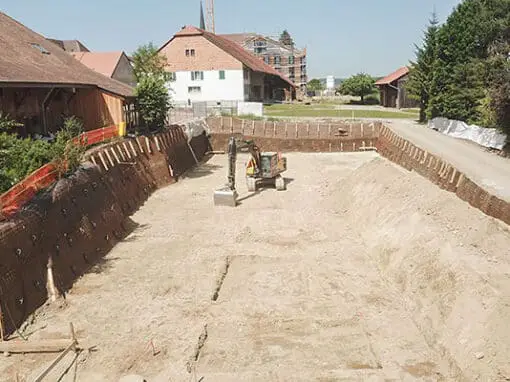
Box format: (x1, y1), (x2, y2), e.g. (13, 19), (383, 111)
(427, 0), (510, 124)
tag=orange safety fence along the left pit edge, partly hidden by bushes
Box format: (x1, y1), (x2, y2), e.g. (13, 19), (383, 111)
(0, 123), (125, 220)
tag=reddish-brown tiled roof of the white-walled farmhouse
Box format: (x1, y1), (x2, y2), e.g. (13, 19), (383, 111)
(159, 26), (296, 87)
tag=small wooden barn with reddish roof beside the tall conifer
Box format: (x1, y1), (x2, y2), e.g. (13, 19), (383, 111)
(375, 66), (419, 109)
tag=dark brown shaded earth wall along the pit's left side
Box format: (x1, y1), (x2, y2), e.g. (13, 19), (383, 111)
(0, 126), (209, 333)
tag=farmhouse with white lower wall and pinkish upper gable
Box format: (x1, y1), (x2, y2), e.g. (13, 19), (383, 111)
(159, 26), (296, 104)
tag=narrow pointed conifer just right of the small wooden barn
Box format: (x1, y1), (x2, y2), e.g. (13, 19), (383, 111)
(406, 12), (439, 122)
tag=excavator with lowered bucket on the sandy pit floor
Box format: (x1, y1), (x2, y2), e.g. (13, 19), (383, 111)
(214, 137), (287, 207)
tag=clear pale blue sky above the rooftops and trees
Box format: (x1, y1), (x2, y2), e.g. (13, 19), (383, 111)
(0, 0), (459, 77)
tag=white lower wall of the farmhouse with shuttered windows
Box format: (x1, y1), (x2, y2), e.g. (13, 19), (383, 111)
(169, 70), (244, 103)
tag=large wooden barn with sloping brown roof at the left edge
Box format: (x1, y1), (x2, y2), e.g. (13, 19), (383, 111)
(0, 12), (134, 136)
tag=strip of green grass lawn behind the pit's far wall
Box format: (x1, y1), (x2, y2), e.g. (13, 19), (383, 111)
(264, 104), (418, 119)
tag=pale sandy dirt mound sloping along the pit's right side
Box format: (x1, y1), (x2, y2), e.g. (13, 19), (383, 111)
(326, 158), (510, 380)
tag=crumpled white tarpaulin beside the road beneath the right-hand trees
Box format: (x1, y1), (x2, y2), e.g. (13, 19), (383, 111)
(429, 118), (506, 150)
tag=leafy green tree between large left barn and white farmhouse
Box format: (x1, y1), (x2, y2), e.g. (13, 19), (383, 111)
(133, 43), (171, 130)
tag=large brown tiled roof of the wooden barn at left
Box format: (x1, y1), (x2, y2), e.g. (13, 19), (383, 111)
(0, 12), (133, 97)
